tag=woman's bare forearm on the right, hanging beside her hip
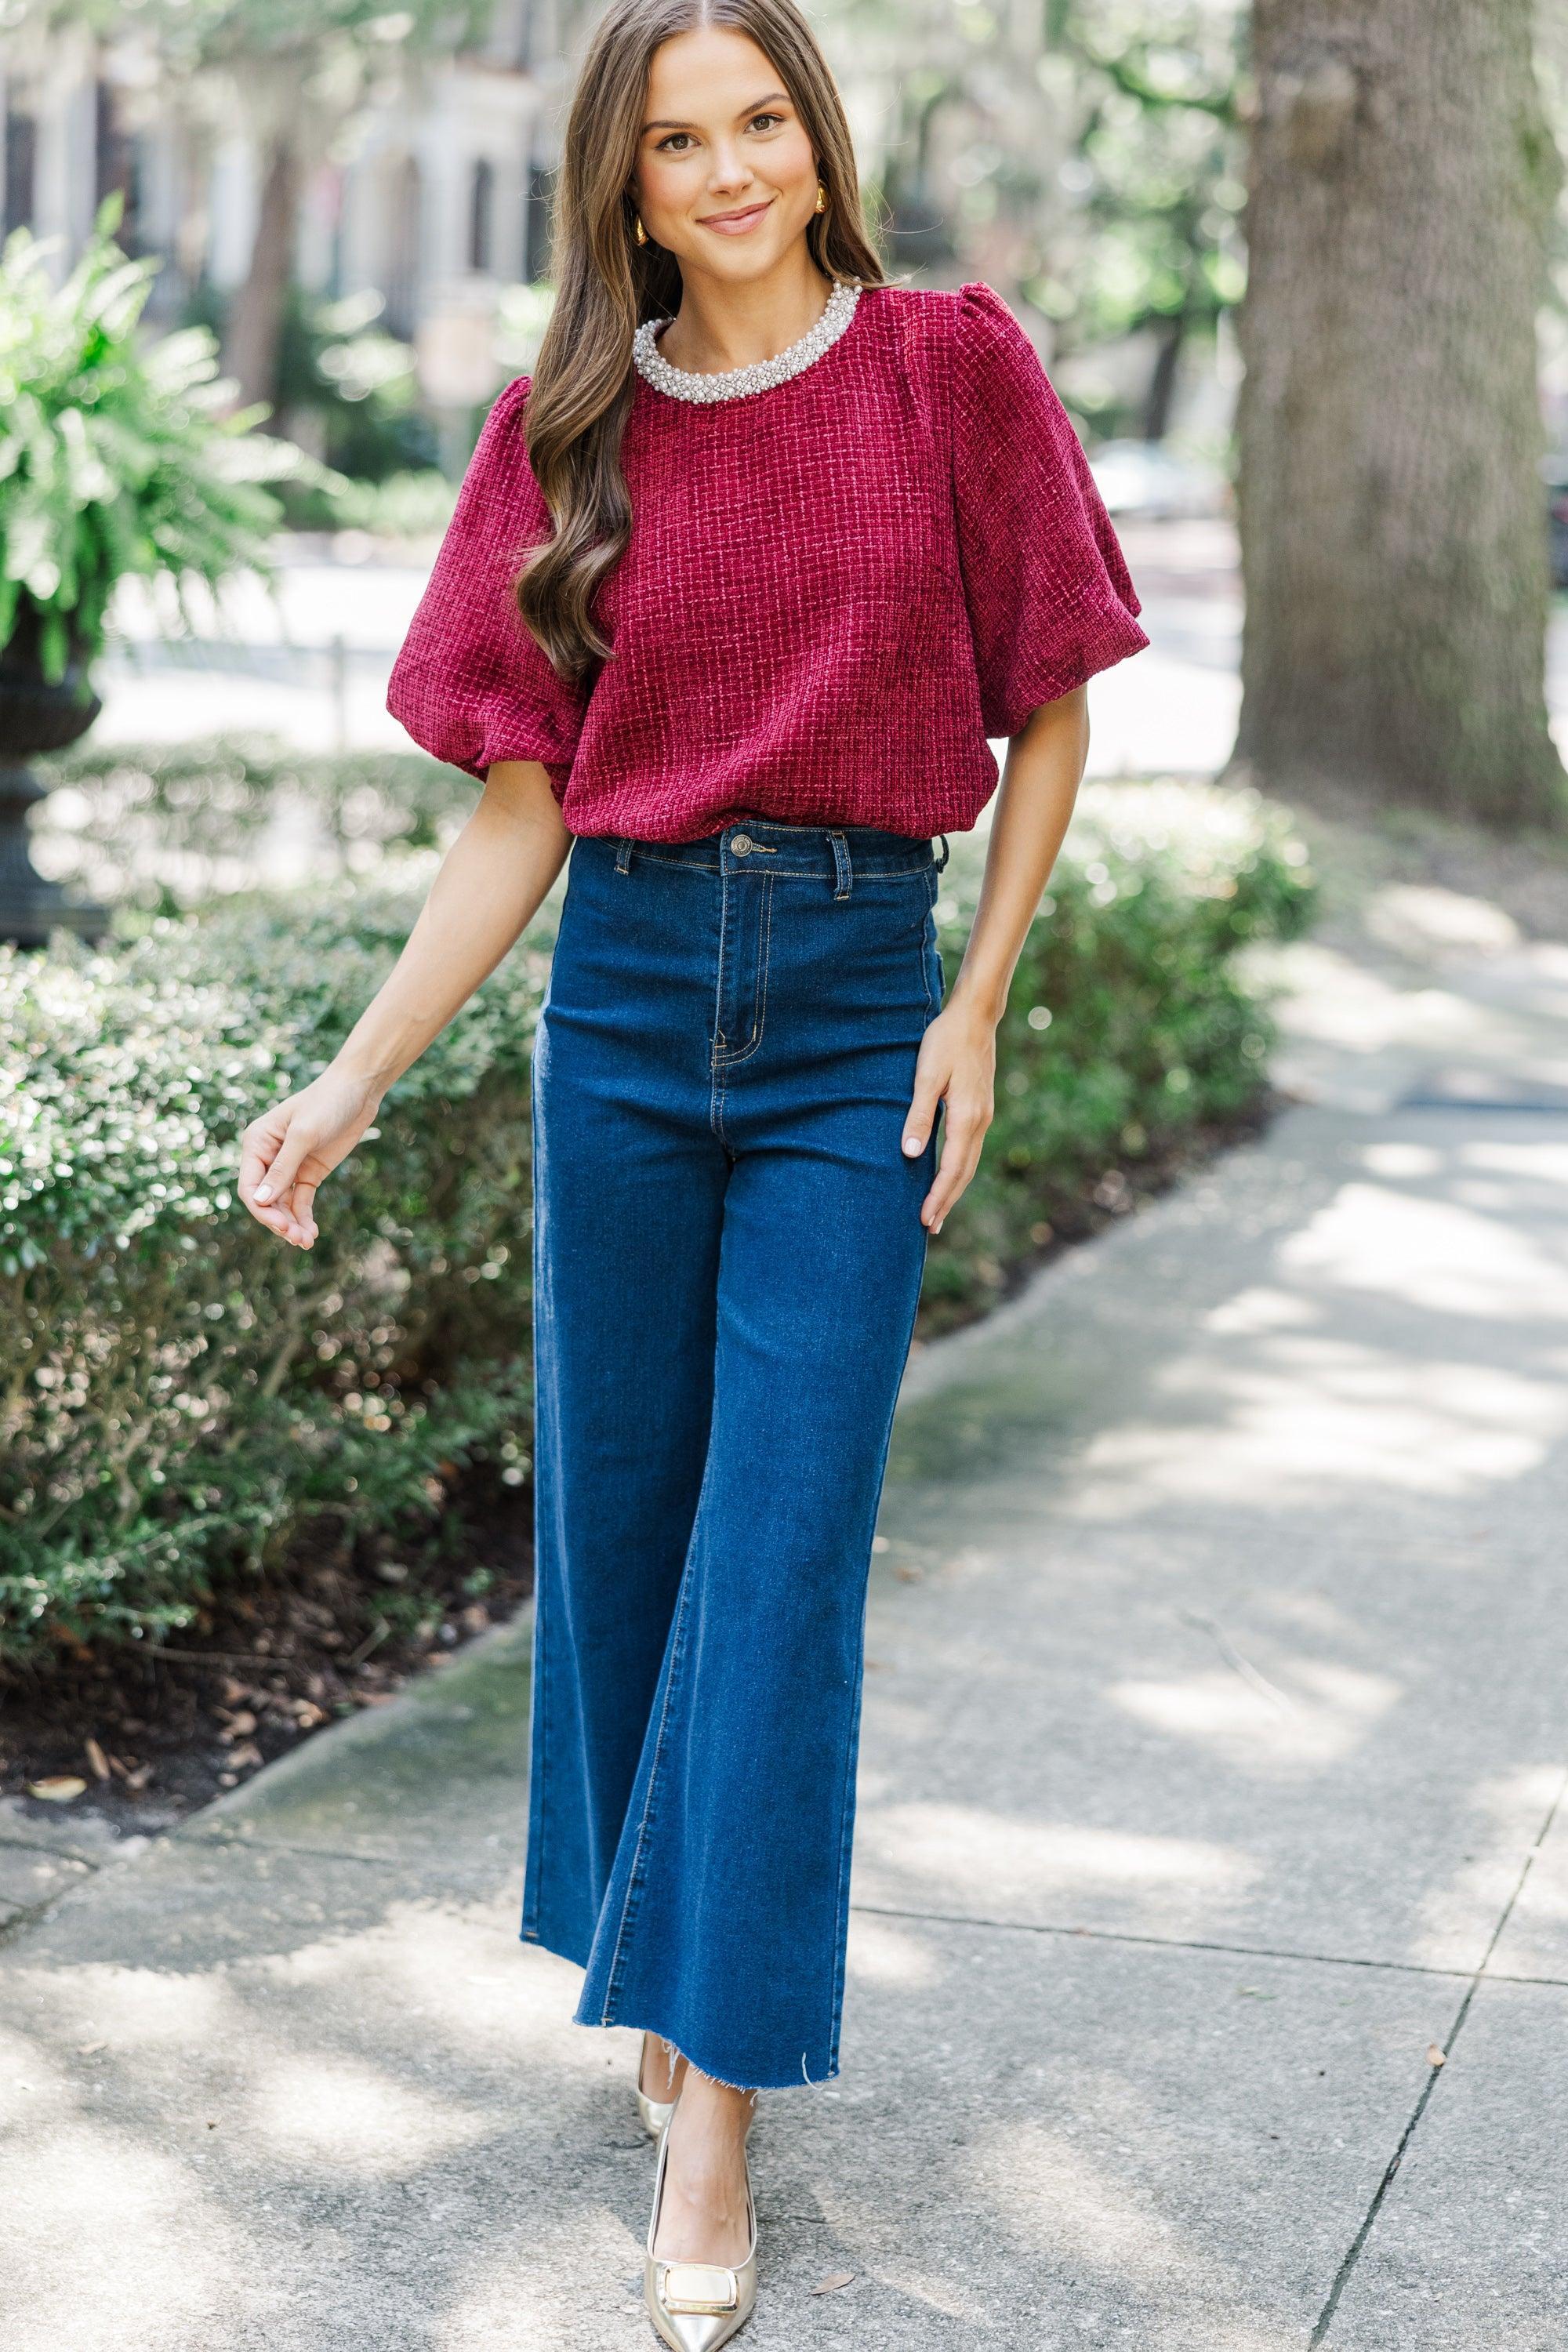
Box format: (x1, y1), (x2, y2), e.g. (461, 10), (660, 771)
(949, 687), (1088, 1023)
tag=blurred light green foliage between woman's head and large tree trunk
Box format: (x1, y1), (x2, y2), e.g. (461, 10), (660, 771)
(839, 0), (1246, 440)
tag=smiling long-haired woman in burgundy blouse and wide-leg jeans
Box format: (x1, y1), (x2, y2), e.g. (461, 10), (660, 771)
(242, 0), (1147, 2352)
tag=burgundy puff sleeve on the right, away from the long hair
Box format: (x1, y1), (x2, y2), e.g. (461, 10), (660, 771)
(949, 285), (1149, 736)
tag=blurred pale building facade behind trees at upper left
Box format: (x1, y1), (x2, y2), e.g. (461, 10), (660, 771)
(0, 0), (569, 334)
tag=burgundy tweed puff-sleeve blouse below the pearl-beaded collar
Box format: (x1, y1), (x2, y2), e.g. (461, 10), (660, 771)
(388, 285), (1147, 842)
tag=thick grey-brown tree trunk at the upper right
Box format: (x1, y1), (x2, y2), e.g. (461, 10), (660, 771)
(1234, 0), (1566, 826)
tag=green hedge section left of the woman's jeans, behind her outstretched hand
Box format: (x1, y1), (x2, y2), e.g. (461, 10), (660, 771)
(0, 884), (548, 1656)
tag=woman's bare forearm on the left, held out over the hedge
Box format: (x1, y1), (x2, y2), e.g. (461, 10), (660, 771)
(336, 760), (572, 1091)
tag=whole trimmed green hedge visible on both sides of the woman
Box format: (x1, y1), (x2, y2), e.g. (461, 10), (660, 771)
(0, 788), (1312, 1658)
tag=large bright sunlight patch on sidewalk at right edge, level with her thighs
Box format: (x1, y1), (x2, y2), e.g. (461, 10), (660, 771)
(1279, 1176), (1568, 1322)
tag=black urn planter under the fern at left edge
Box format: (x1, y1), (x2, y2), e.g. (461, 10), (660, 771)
(0, 607), (108, 948)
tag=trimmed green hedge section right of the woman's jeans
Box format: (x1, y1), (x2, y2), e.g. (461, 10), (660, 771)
(921, 783), (1314, 1331)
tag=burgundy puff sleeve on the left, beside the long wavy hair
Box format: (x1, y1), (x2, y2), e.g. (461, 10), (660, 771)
(386, 376), (588, 800)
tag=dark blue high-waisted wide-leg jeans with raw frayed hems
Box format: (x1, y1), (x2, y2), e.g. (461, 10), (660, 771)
(522, 818), (947, 2086)
